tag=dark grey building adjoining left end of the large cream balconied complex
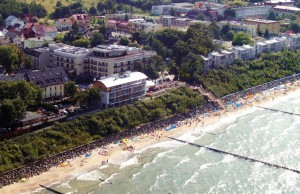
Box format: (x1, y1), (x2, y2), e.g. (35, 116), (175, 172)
(24, 47), (49, 69)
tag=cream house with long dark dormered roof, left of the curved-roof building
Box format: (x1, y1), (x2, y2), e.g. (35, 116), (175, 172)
(25, 67), (70, 98)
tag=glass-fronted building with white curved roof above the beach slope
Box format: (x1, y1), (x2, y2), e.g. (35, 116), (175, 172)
(93, 71), (147, 107)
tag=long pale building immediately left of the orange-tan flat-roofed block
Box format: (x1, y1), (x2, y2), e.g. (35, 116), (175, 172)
(217, 21), (257, 37)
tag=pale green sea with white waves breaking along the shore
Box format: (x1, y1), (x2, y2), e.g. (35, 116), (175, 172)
(35, 91), (300, 194)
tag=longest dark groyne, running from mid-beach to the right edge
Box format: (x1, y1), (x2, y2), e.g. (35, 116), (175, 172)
(168, 137), (300, 174)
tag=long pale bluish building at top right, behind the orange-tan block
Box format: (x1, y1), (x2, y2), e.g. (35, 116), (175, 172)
(231, 5), (271, 19)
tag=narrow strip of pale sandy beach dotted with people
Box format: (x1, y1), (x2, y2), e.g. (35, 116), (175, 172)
(0, 83), (300, 194)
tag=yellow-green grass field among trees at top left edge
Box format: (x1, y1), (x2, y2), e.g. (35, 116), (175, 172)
(19, 0), (99, 15)
